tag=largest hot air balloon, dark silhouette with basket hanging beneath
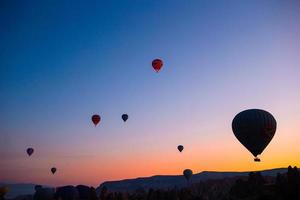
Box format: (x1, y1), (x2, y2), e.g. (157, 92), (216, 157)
(232, 109), (276, 162)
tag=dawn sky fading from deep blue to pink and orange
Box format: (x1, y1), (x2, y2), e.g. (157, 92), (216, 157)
(0, 0), (300, 186)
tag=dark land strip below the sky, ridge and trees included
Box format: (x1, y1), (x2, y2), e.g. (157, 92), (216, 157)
(1, 166), (300, 200)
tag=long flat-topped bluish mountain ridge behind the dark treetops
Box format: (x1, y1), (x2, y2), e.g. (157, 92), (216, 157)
(97, 168), (287, 193)
